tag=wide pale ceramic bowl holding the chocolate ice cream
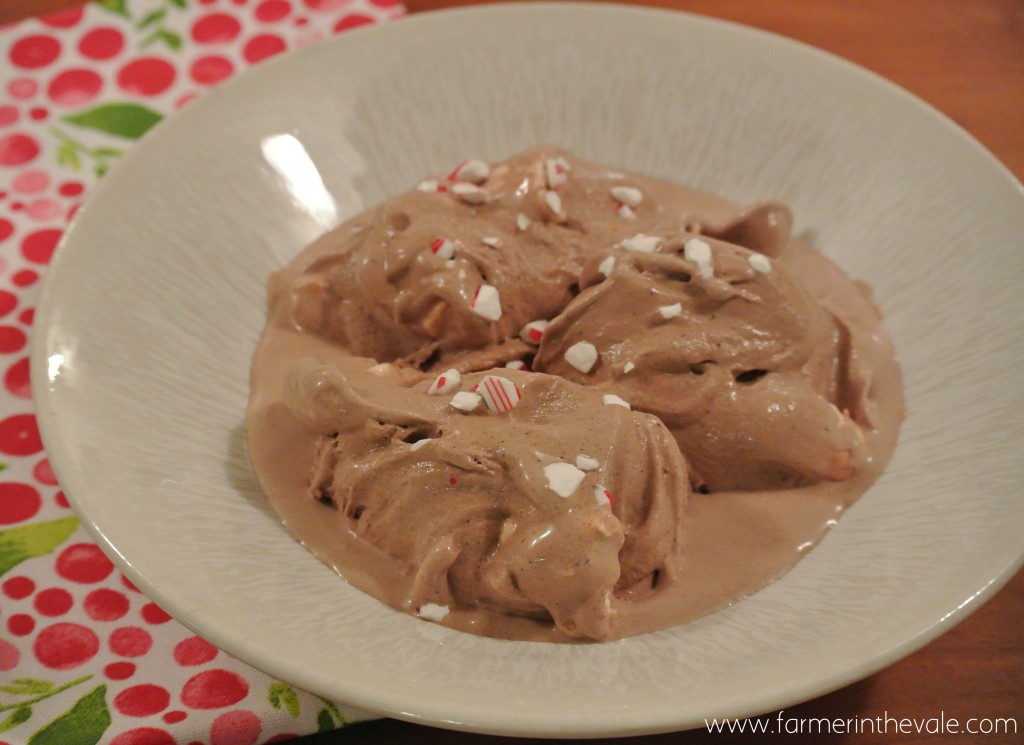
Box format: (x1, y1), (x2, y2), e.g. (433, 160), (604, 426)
(33, 4), (1024, 736)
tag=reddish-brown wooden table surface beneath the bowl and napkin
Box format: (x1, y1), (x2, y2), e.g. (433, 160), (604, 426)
(0, 0), (1024, 745)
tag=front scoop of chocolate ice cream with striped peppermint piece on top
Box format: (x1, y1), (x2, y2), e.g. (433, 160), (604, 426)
(286, 359), (688, 639)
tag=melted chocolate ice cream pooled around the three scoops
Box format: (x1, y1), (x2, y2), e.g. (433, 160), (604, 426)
(247, 149), (903, 642)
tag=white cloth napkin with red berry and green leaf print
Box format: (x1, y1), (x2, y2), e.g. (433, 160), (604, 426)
(0, 0), (404, 745)
